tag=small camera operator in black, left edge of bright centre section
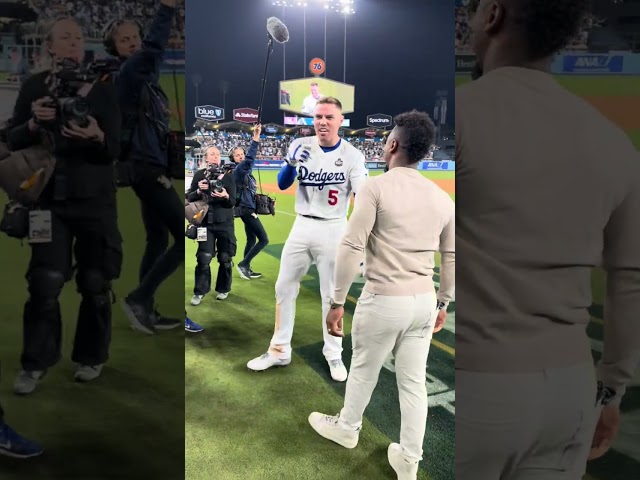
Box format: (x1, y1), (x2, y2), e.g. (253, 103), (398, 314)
(187, 147), (236, 305)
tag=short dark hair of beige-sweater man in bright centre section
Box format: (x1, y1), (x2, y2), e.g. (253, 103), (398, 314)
(394, 110), (436, 163)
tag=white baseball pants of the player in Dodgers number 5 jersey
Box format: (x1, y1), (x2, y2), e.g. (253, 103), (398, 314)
(269, 216), (347, 361)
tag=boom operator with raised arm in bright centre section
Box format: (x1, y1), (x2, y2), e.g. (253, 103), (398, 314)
(230, 125), (269, 280)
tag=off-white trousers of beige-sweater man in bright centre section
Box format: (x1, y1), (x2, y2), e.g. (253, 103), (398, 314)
(340, 291), (437, 460)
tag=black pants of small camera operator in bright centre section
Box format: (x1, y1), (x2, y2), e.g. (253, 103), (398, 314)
(193, 225), (237, 295)
